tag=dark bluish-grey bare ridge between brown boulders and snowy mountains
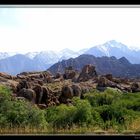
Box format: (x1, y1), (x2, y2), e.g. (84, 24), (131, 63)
(48, 54), (140, 78)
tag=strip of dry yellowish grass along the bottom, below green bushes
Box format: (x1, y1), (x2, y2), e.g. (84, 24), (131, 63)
(0, 123), (140, 135)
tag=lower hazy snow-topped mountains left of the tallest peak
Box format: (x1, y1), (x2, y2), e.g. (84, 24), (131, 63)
(0, 49), (84, 75)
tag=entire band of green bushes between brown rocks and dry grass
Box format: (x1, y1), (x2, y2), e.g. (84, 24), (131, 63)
(0, 86), (140, 132)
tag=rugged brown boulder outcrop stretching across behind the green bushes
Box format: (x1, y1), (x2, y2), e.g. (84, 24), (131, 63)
(0, 64), (140, 109)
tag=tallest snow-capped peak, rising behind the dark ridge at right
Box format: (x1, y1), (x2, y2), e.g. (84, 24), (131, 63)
(85, 40), (140, 64)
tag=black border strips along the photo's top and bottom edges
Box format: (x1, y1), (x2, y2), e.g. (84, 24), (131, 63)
(0, 0), (140, 140)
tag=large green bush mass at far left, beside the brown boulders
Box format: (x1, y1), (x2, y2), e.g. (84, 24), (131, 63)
(0, 87), (47, 127)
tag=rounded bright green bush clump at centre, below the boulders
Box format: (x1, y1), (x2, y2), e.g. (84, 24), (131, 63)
(45, 97), (93, 127)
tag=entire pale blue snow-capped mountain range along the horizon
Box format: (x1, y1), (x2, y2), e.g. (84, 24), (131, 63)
(0, 40), (140, 75)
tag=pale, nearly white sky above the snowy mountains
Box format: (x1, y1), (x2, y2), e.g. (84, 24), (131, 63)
(0, 8), (140, 52)
